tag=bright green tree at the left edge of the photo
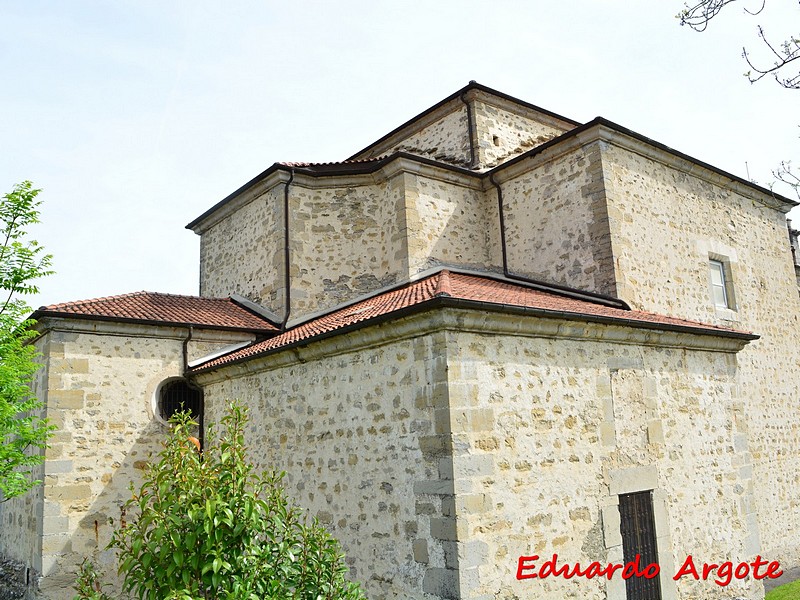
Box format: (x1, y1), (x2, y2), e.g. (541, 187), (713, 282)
(0, 181), (53, 502)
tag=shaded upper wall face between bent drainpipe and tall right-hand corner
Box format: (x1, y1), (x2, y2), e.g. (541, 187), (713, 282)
(500, 144), (615, 295)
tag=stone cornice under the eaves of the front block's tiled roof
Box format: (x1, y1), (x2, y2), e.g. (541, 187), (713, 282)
(195, 298), (754, 385)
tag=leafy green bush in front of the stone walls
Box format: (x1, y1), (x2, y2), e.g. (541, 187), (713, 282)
(76, 402), (363, 600)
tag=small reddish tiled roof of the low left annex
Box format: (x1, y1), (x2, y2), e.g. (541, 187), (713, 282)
(32, 292), (277, 333)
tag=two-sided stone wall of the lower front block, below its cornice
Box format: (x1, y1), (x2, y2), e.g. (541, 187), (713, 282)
(195, 310), (763, 600)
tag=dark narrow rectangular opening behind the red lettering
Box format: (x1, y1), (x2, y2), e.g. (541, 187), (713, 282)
(619, 491), (661, 600)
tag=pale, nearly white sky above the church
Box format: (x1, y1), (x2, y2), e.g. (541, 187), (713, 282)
(0, 0), (800, 307)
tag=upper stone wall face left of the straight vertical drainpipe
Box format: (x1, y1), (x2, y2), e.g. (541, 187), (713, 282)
(200, 185), (284, 315)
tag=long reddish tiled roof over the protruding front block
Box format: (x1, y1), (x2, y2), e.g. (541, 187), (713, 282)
(195, 270), (757, 371)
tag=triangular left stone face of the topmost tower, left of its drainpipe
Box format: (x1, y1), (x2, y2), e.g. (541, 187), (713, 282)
(372, 101), (471, 167)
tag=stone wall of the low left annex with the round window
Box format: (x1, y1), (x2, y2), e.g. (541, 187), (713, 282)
(28, 324), (253, 600)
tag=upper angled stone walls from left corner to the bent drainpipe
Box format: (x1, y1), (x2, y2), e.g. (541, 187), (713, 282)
(201, 166), (501, 322)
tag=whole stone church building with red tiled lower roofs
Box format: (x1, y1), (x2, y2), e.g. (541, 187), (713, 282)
(0, 82), (800, 600)
